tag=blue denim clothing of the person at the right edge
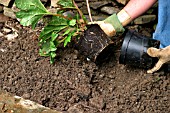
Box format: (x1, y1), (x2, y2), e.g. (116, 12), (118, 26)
(153, 0), (170, 48)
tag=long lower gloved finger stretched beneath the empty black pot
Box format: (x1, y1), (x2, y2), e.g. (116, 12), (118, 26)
(147, 59), (165, 73)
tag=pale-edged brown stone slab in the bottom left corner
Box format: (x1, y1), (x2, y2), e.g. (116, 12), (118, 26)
(0, 89), (62, 113)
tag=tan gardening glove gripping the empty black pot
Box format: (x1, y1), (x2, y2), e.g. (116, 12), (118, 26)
(147, 46), (170, 73)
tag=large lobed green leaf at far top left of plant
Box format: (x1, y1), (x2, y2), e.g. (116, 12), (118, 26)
(15, 0), (49, 28)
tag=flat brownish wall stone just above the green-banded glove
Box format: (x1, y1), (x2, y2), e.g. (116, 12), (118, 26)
(101, 6), (120, 15)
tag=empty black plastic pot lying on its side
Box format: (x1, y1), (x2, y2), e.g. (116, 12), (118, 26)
(119, 31), (160, 68)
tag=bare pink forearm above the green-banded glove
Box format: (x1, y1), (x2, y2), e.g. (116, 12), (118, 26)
(118, 0), (157, 26)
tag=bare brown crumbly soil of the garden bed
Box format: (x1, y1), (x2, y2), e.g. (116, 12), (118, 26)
(0, 20), (170, 113)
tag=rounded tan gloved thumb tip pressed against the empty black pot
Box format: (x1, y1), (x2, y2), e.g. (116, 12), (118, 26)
(147, 47), (161, 57)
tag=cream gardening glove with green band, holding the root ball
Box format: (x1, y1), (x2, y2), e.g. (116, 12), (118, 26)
(89, 10), (131, 37)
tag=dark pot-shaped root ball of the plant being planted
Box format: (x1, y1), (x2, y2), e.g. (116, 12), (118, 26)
(76, 24), (113, 64)
